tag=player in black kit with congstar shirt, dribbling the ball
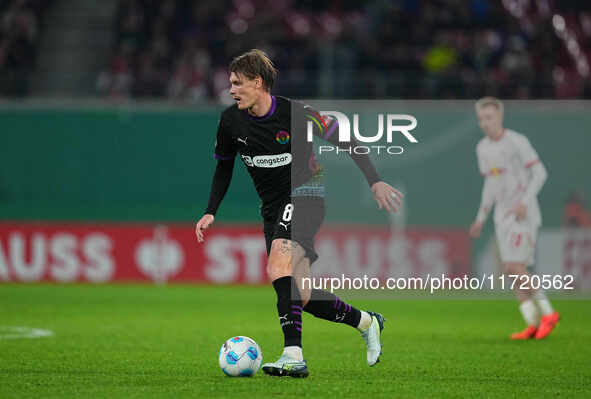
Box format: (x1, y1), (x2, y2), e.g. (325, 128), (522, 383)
(195, 49), (402, 377)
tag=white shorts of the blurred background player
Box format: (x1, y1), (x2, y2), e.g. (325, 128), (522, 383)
(495, 220), (538, 266)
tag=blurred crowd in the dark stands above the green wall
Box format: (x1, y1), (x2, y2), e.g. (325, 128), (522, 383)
(0, 0), (591, 102)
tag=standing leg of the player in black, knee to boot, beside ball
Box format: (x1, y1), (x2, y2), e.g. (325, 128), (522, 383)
(263, 238), (308, 378)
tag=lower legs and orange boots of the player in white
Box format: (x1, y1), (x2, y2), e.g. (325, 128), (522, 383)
(505, 262), (560, 340)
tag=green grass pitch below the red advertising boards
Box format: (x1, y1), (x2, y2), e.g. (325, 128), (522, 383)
(0, 284), (591, 399)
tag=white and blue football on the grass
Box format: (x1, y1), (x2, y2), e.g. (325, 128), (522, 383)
(218, 336), (263, 377)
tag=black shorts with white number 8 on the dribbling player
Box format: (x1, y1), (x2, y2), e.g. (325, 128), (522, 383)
(261, 197), (324, 264)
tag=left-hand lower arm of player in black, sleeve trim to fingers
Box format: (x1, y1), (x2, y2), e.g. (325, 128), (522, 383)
(195, 158), (234, 242)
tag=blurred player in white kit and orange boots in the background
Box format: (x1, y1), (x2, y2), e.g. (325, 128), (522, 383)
(470, 97), (560, 339)
